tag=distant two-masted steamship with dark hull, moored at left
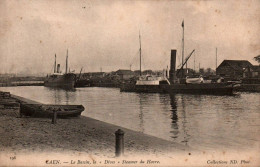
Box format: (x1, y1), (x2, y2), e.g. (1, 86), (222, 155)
(44, 50), (76, 89)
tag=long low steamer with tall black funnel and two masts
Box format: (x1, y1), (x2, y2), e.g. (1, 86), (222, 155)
(120, 22), (234, 95)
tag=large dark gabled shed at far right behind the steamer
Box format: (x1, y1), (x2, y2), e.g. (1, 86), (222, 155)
(216, 60), (253, 79)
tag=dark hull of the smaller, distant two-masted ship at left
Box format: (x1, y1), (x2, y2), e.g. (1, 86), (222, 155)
(44, 74), (76, 88)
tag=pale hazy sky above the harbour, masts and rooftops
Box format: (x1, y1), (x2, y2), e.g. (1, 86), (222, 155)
(0, 0), (260, 74)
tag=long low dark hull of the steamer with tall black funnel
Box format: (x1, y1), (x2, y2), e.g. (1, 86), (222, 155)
(120, 83), (233, 95)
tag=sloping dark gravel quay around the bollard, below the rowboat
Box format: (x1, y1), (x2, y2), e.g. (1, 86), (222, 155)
(0, 92), (191, 157)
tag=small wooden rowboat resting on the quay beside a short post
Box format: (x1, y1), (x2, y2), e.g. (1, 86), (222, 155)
(20, 103), (85, 118)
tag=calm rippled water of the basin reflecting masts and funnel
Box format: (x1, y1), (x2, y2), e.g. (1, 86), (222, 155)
(0, 86), (260, 150)
